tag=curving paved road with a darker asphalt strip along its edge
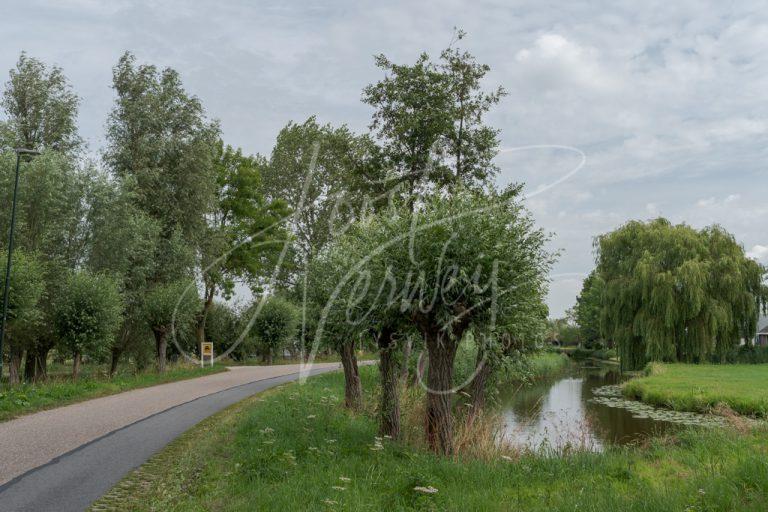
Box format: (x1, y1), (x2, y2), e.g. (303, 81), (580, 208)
(0, 363), (340, 512)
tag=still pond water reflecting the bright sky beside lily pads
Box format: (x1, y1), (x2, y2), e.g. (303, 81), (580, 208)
(503, 363), (678, 451)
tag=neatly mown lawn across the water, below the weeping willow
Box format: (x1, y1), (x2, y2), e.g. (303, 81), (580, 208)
(624, 364), (768, 418)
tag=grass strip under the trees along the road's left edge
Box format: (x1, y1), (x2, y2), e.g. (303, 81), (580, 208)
(0, 364), (226, 421)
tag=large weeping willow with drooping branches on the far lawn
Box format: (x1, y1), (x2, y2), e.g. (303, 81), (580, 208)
(596, 219), (768, 370)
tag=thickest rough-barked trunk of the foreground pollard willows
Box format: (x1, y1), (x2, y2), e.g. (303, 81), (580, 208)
(424, 326), (458, 455)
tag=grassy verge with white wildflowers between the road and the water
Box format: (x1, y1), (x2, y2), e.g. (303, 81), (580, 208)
(94, 367), (768, 512)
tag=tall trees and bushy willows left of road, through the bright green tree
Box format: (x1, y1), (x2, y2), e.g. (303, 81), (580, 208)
(0, 53), (298, 383)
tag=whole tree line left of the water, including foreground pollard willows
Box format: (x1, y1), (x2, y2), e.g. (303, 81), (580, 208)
(0, 32), (554, 454)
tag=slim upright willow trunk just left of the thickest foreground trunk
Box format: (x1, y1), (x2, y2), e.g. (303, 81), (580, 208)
(377, 328), (401, 439)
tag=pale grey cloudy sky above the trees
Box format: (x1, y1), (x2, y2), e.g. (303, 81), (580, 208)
(0, 0), (768, 315)
